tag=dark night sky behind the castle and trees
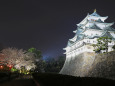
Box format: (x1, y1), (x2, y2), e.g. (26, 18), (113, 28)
(0, 0), (115, 57)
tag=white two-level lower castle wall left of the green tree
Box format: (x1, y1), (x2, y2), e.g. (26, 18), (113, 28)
(66, 39), (96, 58)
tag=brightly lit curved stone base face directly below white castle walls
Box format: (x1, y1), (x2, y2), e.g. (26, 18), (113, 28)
(60, 52), (95, 77)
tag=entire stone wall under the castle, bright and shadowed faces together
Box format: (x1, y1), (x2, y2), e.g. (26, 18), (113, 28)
(60, 51), (115, 80)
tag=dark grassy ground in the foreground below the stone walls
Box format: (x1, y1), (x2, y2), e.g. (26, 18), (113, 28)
(33, 73), (115, 86)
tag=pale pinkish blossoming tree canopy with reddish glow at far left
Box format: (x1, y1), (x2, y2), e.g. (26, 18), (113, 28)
(2, 48), (36, 71)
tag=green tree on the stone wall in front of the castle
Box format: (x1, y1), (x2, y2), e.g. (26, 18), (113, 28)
(92, 36), (112, 53)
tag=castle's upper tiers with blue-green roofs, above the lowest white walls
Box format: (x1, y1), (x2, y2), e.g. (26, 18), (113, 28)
(64, 11), (115, 46)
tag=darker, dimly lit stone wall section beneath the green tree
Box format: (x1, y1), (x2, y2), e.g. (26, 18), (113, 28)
(86, 51), (115, 80)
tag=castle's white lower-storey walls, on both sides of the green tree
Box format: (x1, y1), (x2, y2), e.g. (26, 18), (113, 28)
(65, 38), (114, 58)
